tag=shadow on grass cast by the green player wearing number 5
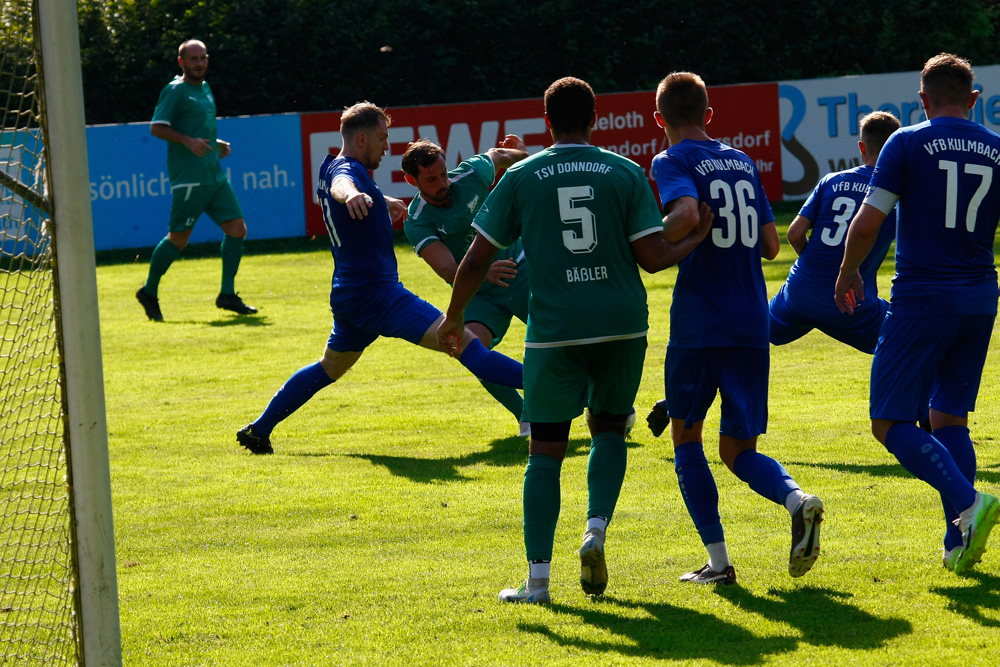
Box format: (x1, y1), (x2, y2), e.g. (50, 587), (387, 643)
(518, 596), (798, 665)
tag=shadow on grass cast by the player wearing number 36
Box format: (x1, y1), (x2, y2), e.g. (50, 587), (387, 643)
(716, 586), (913, 650)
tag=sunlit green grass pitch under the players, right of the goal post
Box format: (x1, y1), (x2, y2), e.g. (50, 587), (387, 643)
(98, 215), (1000, 667)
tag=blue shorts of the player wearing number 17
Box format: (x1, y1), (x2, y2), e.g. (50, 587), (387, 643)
(869, 311), (996, 422)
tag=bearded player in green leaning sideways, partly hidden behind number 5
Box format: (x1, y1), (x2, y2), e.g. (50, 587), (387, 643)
(401, 134), (529, 436)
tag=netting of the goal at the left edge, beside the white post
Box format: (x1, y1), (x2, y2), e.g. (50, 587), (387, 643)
(0, 0), (79, 665)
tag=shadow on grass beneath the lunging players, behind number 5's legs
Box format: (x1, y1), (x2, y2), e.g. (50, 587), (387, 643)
(348, 437), (639, 484)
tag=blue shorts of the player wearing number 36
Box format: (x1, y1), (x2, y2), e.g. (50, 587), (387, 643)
(663, 345), (770, 440)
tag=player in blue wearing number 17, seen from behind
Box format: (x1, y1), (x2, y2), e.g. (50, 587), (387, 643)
(835, 53), (1000, 574)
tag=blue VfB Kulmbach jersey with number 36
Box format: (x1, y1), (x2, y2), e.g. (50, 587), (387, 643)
(652, 139), (774, 349)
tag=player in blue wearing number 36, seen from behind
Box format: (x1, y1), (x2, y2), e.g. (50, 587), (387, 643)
(652, 72), (823, 584)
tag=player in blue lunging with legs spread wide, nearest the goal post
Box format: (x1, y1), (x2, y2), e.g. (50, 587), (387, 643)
(236, 102), (522, 454)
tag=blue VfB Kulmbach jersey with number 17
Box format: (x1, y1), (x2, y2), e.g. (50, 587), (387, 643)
(871, 117), (1000, 315)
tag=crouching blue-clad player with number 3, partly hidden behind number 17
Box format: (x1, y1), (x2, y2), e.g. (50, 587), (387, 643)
(768, 111), (899, 354)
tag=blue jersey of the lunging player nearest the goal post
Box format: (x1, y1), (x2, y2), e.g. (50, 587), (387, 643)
(316, 155), (399, 310)
